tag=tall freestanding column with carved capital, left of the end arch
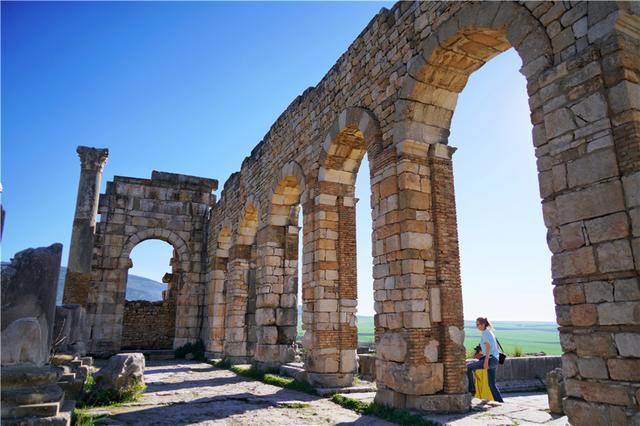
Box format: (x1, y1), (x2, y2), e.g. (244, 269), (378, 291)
(63, 146), (109, 306)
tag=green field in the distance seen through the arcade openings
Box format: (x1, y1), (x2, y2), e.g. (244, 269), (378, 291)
(298, 316), (562, 355)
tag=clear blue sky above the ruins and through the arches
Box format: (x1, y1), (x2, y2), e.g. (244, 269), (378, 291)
(1, 2), (554, 320)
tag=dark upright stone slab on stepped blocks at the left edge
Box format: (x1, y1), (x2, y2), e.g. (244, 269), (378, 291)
(0, 244), (75, 425)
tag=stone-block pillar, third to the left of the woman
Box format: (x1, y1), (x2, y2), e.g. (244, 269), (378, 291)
(255, 225), (298, 371)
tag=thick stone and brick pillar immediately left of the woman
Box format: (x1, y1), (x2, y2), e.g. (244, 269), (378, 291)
(372, 140), (470, 411)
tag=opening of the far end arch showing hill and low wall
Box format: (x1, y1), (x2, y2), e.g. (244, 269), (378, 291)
(121, 239), (180, 350)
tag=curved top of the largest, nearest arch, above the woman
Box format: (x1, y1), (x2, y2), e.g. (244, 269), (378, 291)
(393, 2), (556, 145)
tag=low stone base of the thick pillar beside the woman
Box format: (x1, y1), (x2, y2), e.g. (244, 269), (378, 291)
(375, 385), (471, 413)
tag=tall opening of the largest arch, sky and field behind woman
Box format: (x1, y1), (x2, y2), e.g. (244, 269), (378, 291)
(449, 49), (562, 356)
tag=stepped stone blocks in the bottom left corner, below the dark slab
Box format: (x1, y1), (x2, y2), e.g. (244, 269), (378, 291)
(1, 365), (75, 425)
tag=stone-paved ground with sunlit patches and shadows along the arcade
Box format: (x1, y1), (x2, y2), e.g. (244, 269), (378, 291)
(89, 361), (568, 426)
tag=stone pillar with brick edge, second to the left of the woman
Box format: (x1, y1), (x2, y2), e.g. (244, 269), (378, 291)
(303, 193), (358, 387)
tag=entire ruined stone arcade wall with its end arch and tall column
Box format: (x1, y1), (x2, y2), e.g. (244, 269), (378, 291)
(65, 2), (640, 425)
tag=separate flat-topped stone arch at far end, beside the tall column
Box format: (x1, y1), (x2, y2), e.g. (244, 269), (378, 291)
(87, 171), (217, 355)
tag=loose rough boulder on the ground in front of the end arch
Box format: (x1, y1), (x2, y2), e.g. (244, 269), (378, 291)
(93, 353), (145, 392)
